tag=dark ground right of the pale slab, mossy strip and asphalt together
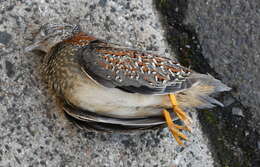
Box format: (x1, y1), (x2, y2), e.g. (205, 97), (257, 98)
(157, 0), (260, 167)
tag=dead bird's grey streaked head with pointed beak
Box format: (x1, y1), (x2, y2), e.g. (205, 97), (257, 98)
(25, 24), (81, 53)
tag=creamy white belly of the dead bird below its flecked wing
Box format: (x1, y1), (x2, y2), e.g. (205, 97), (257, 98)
(64, 74), (167, 118)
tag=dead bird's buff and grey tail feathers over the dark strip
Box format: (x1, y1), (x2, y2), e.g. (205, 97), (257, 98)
(176, 73), (231, 109)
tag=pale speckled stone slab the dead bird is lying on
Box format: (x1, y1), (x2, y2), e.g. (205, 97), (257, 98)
(0, 0), (213, 167)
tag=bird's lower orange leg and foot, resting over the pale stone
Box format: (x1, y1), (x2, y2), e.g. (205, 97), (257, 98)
(162, 109), (188, 145)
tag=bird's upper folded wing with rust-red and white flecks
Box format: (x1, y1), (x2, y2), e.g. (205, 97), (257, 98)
(79, 40), (193, 94)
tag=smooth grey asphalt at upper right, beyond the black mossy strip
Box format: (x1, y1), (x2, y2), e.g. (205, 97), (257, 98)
(186, 0), (260, 130)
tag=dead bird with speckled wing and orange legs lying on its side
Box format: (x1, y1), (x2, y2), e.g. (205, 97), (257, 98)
(25, 24), (231, 145)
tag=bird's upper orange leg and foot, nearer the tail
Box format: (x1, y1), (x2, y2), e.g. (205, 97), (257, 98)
(169, 94), (192, 131)
